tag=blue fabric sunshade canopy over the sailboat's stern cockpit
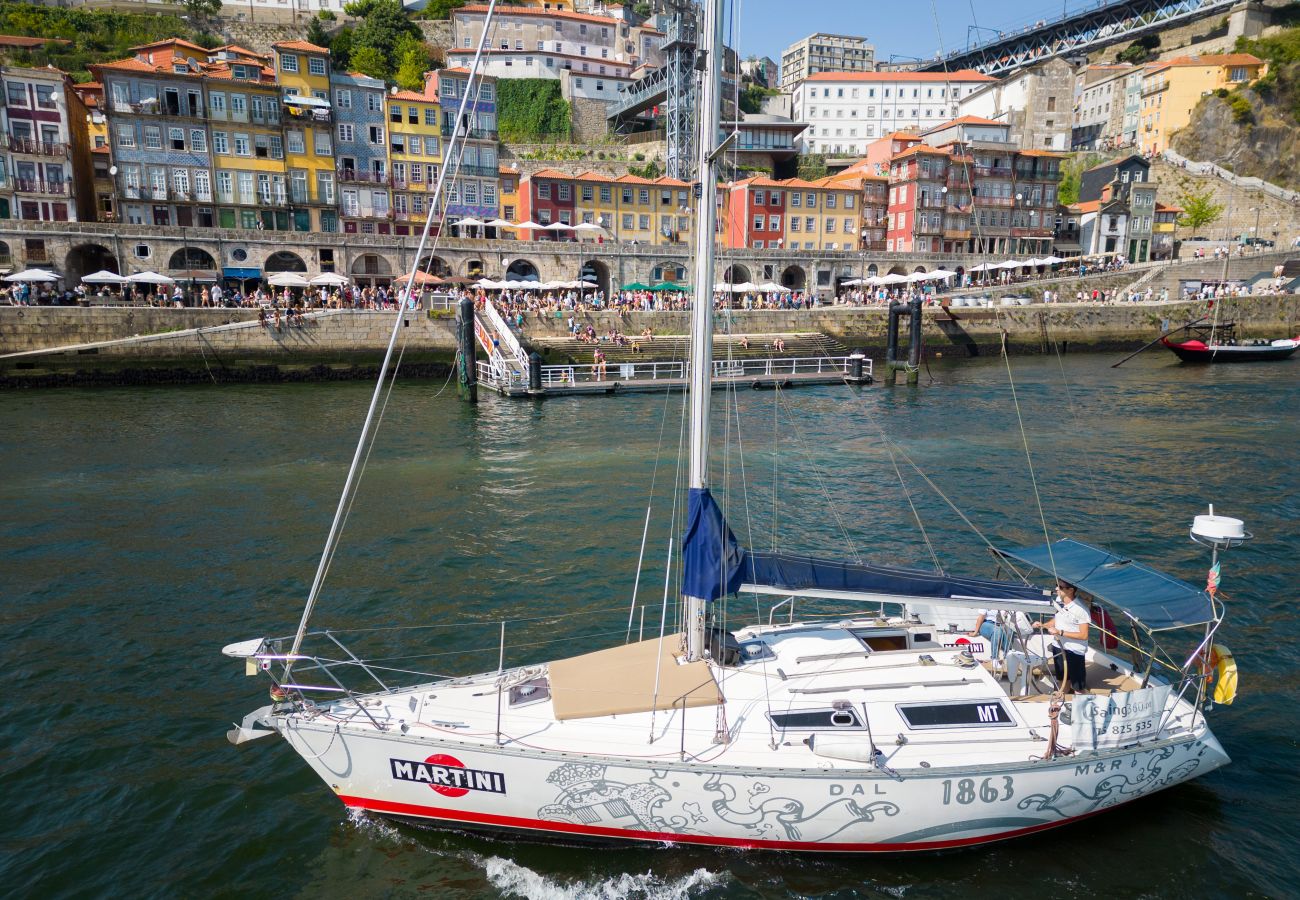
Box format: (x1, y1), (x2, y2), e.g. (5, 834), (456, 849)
(998, 538), (1217, 631)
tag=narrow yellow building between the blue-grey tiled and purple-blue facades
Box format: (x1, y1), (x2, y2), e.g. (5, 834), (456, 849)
(387, 73), (445, 239)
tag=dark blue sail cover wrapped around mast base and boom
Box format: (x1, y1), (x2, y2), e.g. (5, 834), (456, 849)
(681, 488), (1048, 606)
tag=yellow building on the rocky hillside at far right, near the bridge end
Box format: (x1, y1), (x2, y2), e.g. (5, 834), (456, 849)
(1138, 53), (1266, 153)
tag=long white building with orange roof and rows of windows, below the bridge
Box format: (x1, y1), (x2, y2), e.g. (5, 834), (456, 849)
(792, 69), (996, 156)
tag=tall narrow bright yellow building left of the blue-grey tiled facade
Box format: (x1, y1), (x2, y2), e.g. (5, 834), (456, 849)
(270, 40), (338, 232)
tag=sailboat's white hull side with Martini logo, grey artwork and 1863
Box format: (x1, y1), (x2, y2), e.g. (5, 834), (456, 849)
(274, 718), (1229, 853)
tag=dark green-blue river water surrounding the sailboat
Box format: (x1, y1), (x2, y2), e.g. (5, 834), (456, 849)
(0, 352), (1300, 899)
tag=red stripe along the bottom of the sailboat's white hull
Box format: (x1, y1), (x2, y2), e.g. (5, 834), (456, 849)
(339, 796), (1097, 853)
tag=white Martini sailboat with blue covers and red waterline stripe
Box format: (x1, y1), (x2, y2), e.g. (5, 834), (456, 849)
(224, 0), (1249, 853)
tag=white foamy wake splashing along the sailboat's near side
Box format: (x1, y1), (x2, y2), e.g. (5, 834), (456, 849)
(347, 809), (728, 900)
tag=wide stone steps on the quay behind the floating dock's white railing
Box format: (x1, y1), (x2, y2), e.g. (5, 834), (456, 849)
(528, 332), (849, 365)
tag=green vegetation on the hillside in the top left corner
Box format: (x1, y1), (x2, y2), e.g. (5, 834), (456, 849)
(0, 0), (213, 81)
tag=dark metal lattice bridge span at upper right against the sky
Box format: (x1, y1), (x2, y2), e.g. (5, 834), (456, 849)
(918, 0), (1242, 77)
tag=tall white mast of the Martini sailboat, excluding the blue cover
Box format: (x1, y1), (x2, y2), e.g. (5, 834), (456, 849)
(684, 0), (723, 661)
